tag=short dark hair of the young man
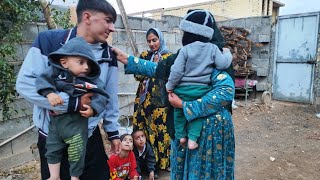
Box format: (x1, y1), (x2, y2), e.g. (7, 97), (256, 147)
(76, 0), (117, 23)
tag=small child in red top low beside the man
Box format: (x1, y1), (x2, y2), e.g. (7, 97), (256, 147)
(108, 134), (139, 180)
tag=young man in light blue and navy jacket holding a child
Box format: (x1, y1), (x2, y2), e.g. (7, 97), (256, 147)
(16, 0), (120, 180)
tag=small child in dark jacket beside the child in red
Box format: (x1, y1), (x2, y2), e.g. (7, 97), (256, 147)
(131, 130), (158, 180)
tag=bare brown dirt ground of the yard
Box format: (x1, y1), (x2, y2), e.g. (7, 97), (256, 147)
(0, 101), (320, 180)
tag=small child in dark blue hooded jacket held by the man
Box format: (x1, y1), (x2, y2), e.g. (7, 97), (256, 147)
(36, 37), (109, 180)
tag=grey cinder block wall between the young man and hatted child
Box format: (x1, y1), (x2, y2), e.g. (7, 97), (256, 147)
(110, 15), (182, 115)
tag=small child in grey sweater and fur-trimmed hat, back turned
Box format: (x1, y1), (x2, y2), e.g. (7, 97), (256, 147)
(166, 10), (232, 149)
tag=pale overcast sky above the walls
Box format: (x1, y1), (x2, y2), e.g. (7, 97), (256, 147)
(49, 0), (320, 15)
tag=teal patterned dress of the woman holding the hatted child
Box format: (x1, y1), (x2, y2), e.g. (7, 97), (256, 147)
(126, 56), (235, 180)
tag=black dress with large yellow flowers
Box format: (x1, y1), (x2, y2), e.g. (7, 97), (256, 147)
(133, 51), (171, 169)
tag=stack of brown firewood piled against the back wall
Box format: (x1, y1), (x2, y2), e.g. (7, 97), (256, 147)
(220, 26), (262, 76)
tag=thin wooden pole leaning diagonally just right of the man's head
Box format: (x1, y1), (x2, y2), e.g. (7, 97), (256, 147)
(117, 0), (139, 56)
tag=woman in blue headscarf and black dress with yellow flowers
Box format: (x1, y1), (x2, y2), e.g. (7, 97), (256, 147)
(133, 28), (171, 170)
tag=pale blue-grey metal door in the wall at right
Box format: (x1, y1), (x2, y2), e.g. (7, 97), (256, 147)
(273, 13), (319, 103)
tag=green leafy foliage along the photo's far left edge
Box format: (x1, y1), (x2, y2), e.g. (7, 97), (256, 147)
(0, 0), (39, 120)
